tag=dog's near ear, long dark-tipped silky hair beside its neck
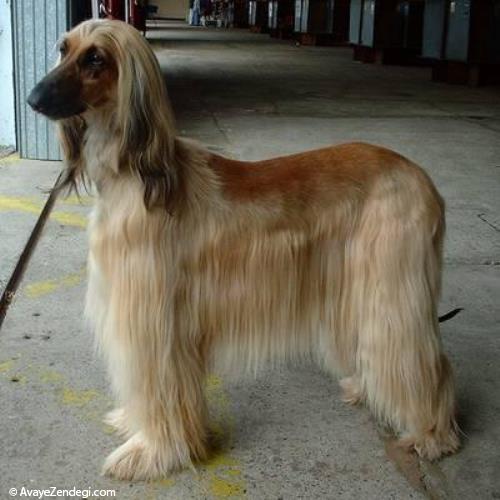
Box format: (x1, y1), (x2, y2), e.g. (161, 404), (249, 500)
(117, 32), (177, 208)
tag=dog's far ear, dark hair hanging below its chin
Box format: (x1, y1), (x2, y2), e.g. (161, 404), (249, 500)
(55, 116), (86, 191)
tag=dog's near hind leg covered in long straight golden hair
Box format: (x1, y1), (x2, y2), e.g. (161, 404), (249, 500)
(355, 182), (458, 460)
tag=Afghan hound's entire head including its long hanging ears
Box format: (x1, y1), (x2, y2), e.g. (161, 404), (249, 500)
(28, 20), (175, 204)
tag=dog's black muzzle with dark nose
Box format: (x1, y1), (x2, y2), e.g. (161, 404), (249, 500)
(27, 68), (86, 120)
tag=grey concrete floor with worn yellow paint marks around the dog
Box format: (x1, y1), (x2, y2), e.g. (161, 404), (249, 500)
(0, 22), (500, 500)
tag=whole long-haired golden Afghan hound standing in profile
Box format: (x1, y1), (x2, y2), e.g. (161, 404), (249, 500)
(28, 20), (459, 480)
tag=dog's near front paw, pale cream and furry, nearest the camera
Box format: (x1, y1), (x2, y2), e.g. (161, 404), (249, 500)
(102, 434), (169, 481)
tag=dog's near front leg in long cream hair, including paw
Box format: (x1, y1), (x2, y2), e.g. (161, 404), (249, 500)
(96, 246), (207, 480)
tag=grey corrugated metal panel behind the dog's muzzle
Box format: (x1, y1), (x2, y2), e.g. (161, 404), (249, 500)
(12, 0), (69, 160)
